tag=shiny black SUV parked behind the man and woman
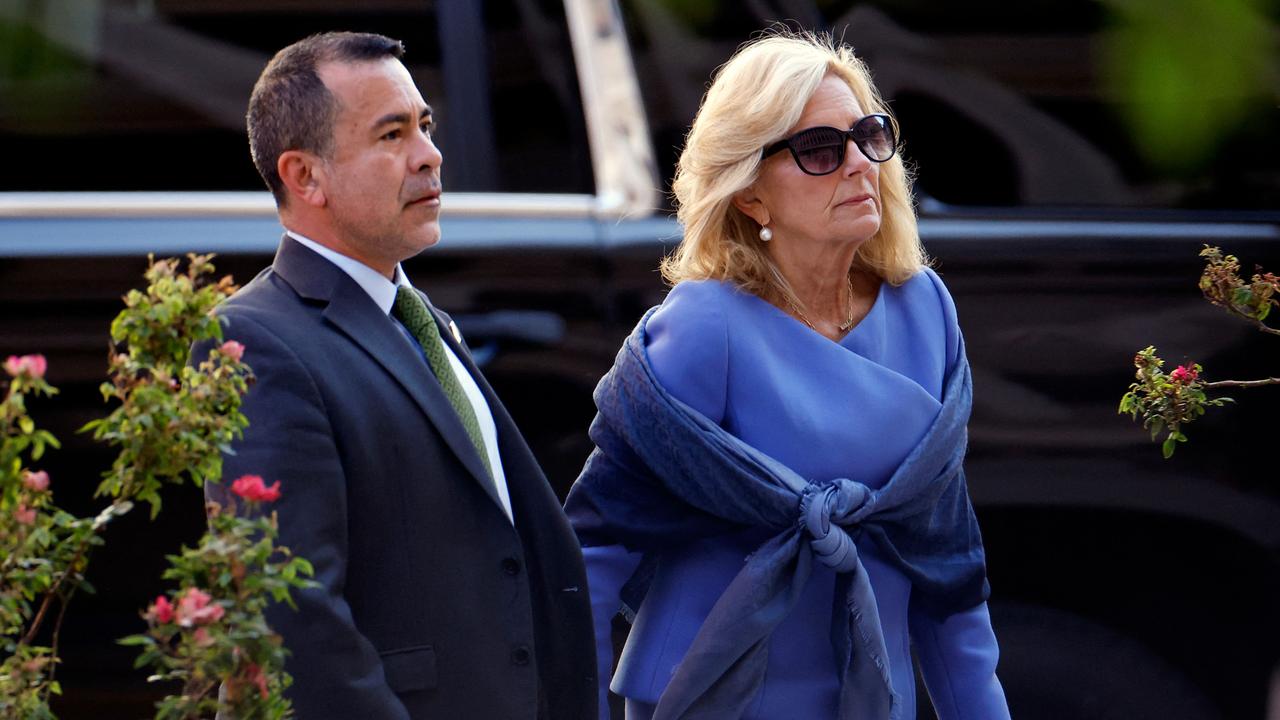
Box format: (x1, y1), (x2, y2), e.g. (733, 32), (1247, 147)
(0, 0), (1280, 720)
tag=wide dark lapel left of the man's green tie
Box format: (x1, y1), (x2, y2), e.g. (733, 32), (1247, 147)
(273, 236), (500, 507)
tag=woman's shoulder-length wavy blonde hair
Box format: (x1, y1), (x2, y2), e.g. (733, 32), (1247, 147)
(662, 29), (928, 298)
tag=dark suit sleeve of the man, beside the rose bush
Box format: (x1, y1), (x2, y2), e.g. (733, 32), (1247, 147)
(203, 314), (408, 720)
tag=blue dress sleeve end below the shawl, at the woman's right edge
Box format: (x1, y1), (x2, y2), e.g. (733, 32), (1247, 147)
(910, 602), (1009, 720)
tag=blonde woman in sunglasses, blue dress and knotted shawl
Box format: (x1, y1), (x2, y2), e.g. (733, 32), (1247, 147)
(567, 32), (1009, 720)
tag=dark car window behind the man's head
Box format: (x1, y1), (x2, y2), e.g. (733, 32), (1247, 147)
(0, 0), (591, 192)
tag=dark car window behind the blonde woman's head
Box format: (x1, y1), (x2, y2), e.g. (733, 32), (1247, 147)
(622, 0), (1280, 209)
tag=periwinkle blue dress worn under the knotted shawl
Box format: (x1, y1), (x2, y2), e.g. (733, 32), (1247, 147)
(584, 269), (1009, 720)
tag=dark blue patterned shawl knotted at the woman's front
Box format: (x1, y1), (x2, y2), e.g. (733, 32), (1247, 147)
(566, 310), (988, 720)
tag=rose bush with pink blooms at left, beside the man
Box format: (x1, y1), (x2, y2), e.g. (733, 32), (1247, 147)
(0, 255), (311, 720)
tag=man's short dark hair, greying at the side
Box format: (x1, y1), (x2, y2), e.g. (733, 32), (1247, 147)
(246, 32), (404, 208)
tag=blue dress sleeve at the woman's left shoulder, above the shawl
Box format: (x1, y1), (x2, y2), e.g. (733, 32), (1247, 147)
(645, 281), (728, 423)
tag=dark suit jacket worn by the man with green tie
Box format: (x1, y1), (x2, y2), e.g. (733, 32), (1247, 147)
(202, 237), (596, 720)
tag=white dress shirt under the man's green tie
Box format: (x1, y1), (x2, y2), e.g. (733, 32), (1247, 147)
(285, 231), (516, 524)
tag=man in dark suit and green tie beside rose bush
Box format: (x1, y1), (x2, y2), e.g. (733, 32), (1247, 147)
(210, 33), (596, 720)
